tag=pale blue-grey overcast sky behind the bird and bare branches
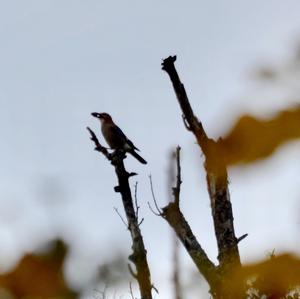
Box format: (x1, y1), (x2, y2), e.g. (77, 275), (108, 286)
(0, 0), (300, 298)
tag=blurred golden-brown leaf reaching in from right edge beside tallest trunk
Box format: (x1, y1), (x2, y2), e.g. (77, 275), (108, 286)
(220, 106), (300, 165)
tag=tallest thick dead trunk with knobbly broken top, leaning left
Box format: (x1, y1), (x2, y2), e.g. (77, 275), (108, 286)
(162, 56), (240, 284)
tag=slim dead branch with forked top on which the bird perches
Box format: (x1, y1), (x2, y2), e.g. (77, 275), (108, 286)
(87, 128), (153, 299)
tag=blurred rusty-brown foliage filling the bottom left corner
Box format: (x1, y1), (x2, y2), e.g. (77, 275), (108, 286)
(0, 240), (78, 299)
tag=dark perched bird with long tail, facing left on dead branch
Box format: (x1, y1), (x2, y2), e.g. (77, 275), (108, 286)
(92, 112), (147, 164)
